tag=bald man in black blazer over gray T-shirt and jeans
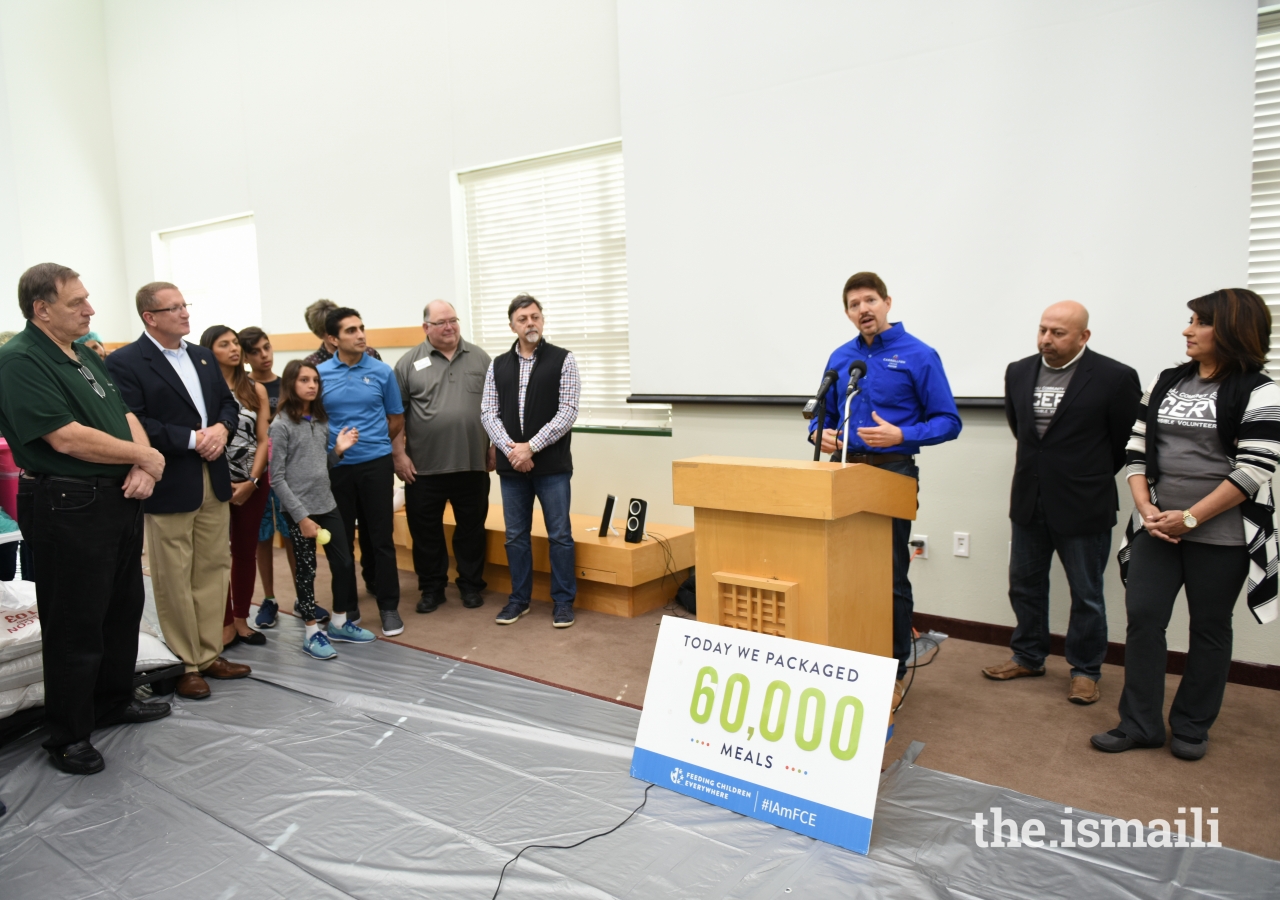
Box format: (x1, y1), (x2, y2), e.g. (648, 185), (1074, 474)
(982, 301), (1142, 704)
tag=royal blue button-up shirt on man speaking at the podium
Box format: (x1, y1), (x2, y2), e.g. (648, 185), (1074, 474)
(809, 323), (960, 456)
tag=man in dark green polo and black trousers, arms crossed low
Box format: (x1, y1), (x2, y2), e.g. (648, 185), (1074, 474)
(0, 262), (169, 775)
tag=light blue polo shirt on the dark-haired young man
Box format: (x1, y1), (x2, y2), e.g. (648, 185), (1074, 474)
(316, 353), (404, 466)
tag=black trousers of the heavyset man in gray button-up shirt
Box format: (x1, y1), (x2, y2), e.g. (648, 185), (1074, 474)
(404, 472), (489, 594)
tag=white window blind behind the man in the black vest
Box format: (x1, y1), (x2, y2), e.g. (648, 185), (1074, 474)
(458, 141), (671, 428)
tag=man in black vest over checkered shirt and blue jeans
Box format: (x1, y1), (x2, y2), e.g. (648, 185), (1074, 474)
(480, 293), (580, 629)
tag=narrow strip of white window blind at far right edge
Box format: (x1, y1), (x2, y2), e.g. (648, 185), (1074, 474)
(1249, 13), (1280, 375)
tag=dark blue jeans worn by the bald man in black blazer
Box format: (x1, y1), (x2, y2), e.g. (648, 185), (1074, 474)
(1009, 501), (1111, 681)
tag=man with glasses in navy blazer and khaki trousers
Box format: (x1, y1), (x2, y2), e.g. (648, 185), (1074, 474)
(106, 282), (250, 700)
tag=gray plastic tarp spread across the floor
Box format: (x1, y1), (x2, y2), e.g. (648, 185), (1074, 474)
(0, 617), (1280, 900)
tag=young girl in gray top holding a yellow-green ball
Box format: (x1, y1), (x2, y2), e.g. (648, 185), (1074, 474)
(271, 360), (374, 659)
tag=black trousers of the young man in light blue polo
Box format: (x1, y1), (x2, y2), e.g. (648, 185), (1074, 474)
(329, 453), (399, 609)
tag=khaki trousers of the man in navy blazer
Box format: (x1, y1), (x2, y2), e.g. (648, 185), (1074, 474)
(146, 466), (232, 672)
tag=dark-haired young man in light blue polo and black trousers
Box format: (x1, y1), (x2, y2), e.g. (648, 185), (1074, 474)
(316, 306), (404, 638)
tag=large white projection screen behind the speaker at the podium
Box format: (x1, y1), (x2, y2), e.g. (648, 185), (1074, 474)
(618, 0), (1257, 397)
